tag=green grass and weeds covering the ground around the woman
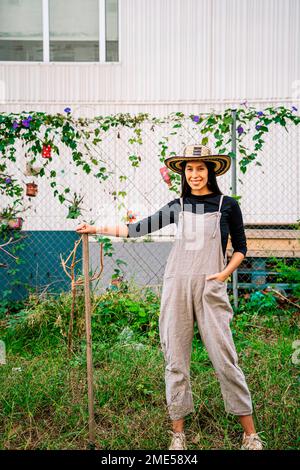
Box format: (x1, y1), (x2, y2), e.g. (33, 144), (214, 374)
(0, 284), (300, 450)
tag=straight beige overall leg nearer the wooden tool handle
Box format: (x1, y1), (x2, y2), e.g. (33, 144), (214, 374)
(159, 277), (195, 420)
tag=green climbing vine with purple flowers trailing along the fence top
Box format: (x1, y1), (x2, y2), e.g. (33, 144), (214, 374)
(0, 101), (300, 226)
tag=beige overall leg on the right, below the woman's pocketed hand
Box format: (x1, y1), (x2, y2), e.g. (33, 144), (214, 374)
(196, 278), (253, 416)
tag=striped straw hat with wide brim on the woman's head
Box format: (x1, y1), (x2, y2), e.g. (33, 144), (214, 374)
(164, 144), (231, 176)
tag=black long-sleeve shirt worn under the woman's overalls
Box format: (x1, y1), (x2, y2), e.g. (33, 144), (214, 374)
(126, 193), (247, 256)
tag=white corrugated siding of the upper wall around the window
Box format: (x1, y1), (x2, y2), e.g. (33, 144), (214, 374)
(0, 0), (300, 114)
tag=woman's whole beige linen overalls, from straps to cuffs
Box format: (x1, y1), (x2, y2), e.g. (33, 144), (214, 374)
(159, 194), (253, 420)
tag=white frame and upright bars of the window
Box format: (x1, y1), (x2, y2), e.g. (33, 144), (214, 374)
(0, 0), (122, 66)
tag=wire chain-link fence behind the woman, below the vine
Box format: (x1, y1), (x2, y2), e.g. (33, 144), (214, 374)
(0, 110), (300, 302)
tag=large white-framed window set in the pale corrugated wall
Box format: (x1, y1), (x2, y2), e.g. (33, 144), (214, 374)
(0, 0), (119, 62)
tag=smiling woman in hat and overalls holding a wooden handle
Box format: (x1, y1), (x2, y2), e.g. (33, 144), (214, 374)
(76, 145), (262, 450)
